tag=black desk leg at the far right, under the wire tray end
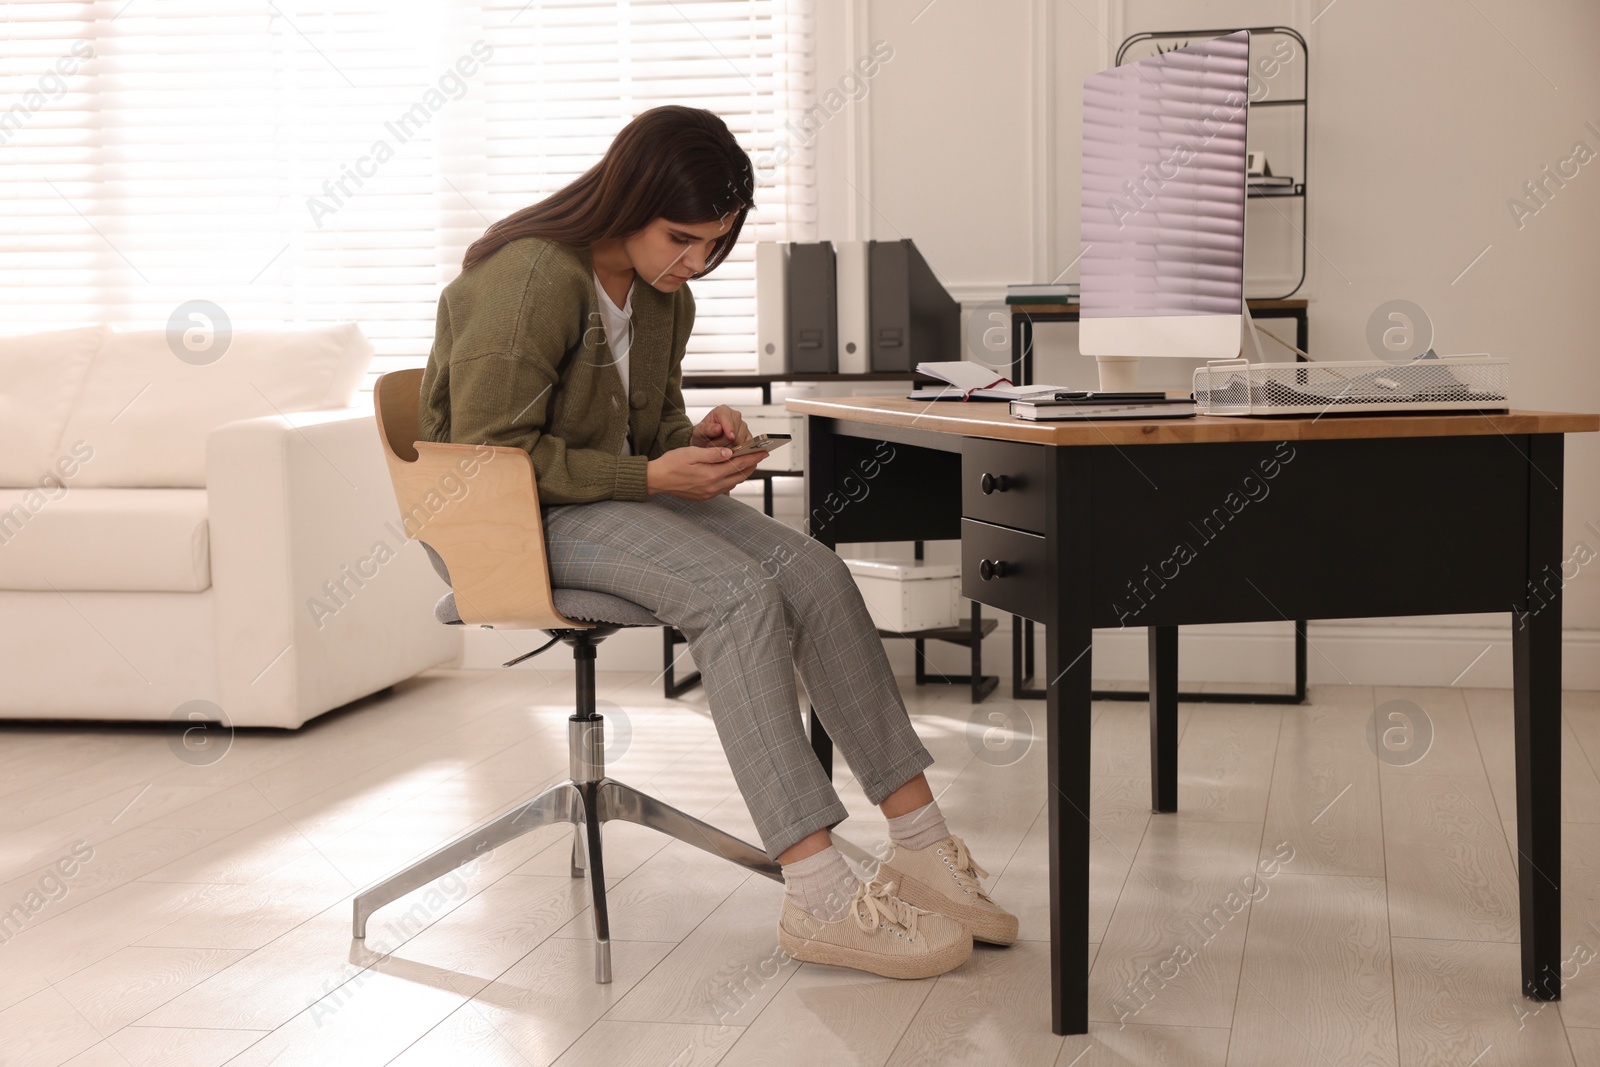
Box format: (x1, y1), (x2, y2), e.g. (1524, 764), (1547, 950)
(1512, 434), (1562, 1000)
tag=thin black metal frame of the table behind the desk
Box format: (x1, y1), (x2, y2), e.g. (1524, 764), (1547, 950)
(1011, 299), (1310, 704)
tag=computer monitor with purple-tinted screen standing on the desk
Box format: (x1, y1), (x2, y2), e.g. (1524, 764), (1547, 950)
(1078, 30), (1250, 389)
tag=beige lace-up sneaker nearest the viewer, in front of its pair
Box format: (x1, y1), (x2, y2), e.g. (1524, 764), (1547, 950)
(778, 881), (973, 977)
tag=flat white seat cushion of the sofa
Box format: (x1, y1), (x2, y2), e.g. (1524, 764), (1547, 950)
(0, 485), (211, 593)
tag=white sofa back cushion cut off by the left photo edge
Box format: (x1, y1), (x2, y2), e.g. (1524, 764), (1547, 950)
(0, 326), (107, 486)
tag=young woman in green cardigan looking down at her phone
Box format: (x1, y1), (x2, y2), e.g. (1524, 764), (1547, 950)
(421, 106), (1016, 977)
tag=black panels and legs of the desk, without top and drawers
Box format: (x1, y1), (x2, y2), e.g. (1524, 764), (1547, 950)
(806, 414), (1563, 1033)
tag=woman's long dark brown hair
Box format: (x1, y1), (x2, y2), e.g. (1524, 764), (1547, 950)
(461, 104), (755, 277)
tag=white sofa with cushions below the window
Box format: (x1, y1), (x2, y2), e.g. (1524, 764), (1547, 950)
(0, 325), (461, 728)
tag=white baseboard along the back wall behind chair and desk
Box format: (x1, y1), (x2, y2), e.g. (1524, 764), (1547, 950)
(458, 613), (1600, 691)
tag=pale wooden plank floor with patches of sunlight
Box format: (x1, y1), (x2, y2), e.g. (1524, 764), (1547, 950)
(0, 670), (1600, 1067)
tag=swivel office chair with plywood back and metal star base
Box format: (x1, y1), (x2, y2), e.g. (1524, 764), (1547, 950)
(355, 370), (782, 982)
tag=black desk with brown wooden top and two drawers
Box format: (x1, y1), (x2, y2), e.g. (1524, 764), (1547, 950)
(789, 397), (1600, 1033)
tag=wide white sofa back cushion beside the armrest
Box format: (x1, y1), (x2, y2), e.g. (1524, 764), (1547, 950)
(58, 323), (373, 486)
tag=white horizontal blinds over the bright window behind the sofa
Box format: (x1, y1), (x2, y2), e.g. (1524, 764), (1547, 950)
(0, 0), (816, 389)
